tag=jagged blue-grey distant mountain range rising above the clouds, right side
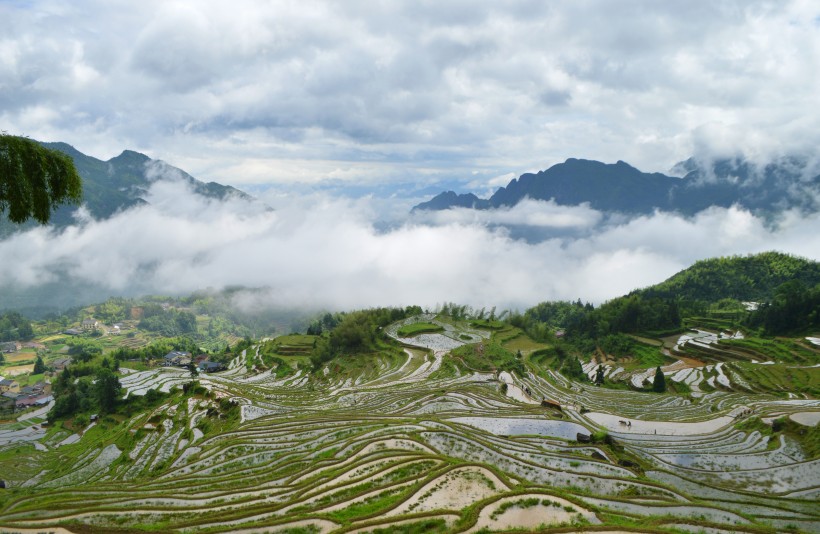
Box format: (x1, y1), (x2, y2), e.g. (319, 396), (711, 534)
(413, 157), (820, 215)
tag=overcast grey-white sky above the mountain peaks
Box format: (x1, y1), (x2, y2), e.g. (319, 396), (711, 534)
(0, 0), (820, 190)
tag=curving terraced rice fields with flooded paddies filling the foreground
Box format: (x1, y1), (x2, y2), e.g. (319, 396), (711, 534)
(0, 316), (820, 533)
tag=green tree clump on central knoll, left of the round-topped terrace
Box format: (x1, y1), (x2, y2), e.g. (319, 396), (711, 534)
(310, 306), (422, 369)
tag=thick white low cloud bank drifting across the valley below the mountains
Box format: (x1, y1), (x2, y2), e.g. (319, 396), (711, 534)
(0, 181), (820, 309)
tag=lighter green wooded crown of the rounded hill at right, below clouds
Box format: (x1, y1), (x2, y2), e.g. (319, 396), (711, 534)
(637, 252), (820, 302)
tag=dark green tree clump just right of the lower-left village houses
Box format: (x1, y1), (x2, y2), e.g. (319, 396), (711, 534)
(48, 358), (122, 422)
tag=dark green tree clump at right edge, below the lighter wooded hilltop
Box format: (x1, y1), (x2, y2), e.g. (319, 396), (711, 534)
(746, 280), (820, 335)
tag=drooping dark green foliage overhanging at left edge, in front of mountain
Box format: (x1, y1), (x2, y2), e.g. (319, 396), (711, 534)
(0, 133), (83, 223)
